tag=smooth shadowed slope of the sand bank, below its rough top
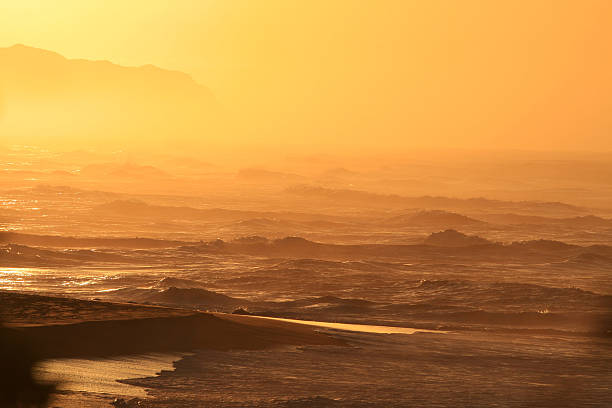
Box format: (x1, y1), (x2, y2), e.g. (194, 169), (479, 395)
(19, 313), (341, 358)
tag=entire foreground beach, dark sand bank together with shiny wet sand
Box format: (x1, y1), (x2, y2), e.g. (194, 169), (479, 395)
(3, 292), (612, 408)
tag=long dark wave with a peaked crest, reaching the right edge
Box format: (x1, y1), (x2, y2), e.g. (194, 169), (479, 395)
(181, 234), (612, 263)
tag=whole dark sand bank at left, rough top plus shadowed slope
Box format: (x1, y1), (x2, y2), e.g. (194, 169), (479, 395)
(0, 292), (343, 358)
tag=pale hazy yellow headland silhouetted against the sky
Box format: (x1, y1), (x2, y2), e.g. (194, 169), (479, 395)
(0, 45), (218, 149)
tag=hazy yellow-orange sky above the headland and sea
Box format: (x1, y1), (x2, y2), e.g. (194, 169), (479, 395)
(0, 0), (612, 150)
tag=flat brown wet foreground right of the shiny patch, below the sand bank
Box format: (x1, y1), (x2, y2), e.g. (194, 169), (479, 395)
(122, 329), (612, 408)
